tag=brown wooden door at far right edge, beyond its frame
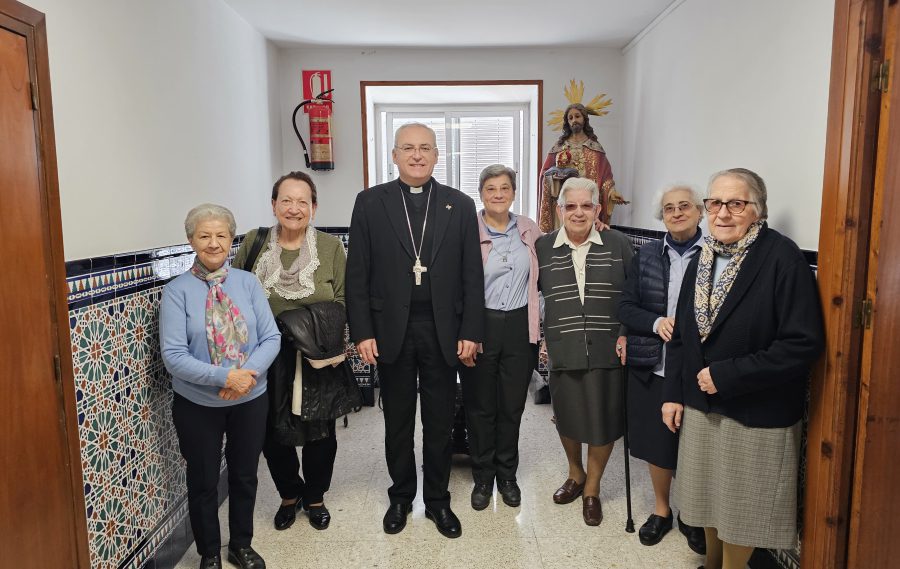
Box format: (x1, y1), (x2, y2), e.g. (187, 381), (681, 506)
(847, 0), (900, 568)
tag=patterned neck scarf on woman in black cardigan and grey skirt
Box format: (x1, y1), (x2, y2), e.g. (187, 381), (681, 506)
(694, 220), (766, 342)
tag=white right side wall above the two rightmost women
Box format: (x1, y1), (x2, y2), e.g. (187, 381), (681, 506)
(613, 0), (834, 249)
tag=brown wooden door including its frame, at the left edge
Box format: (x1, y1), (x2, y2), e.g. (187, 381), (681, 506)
(0, 0), (88, 569)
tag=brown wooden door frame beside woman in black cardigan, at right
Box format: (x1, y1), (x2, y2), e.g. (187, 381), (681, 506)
(800, 0), (884, 569)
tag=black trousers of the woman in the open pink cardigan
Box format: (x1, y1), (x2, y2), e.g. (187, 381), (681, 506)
(460, 306), (538, 484)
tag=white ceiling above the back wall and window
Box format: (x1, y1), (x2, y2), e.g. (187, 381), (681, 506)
(225, 0), (683, 48)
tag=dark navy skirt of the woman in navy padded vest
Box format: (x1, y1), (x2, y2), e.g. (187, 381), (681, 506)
(628, 371), (678, 470)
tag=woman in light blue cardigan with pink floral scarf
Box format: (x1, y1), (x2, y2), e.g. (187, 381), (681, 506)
(159, 204), (281, 569)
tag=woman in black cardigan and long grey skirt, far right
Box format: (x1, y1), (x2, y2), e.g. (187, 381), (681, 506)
(662, 168), (824, 569)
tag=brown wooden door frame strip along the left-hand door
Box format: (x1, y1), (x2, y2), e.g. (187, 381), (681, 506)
(0, 0), (90, 569)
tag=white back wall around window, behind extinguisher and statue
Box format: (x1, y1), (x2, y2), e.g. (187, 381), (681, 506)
(280, 48), (624, 227)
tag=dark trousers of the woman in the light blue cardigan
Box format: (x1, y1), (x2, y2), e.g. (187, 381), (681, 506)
(172, 393), (269, 555)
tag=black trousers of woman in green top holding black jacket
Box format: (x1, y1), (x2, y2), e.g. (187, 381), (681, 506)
(263, 421), (337, 506)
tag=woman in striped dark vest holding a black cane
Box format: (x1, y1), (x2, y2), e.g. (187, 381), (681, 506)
(536, 178), (634, 526)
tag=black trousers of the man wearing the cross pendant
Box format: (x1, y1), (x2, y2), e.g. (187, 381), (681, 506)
(378, 320), (457, 508)
